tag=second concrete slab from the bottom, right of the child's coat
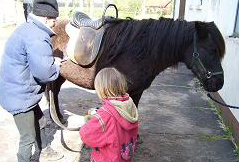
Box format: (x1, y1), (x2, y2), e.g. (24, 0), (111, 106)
(140, 105), (223, 136)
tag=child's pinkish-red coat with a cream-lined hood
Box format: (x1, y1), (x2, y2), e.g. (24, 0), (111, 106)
(80, 94), (138, 162)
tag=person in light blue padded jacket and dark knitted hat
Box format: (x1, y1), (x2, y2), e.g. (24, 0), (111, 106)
(0, 0), (62, 162)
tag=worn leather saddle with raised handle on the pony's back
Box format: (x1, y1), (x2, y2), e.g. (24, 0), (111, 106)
(69, 4), (118, 66)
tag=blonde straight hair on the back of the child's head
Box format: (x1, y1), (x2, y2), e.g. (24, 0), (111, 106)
(94, 68), (127, 99)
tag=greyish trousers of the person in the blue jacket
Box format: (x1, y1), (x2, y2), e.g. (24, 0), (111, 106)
(13, 105), (48, 162)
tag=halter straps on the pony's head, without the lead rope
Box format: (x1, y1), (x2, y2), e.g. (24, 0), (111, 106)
(191, 32), (223, 79)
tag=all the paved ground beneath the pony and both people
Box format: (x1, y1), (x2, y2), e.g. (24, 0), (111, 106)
(0, 26), (237, 162)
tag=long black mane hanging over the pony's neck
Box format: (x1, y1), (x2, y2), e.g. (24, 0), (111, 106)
(102, 18), (195, 67)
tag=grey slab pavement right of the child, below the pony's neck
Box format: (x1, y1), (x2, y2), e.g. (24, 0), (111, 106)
(135, 66), (237, 162)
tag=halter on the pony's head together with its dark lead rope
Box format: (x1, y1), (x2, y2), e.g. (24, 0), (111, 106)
(191, 31), (239, 109)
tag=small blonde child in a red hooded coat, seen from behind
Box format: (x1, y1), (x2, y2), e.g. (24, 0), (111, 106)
(80, 68), (138, 162)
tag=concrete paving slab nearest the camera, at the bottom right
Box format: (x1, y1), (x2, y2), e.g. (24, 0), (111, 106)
(133, 132), (236, 162)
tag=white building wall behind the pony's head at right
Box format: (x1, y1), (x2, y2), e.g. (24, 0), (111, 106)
(174, 0), (239, 121)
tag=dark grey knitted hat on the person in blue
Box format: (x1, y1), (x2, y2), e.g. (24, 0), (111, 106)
(32, 0), (59, 18)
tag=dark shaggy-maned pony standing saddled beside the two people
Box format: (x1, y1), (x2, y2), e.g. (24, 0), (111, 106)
(52, 18), (225, 130)
